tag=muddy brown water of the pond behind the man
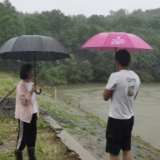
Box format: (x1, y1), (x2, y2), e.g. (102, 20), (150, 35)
(51, 84), (160, 148)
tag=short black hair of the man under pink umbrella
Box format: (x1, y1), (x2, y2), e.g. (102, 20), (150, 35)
(116, 50), (131, 67)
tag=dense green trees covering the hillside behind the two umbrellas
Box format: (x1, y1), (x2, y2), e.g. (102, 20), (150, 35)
(0, 0), (160, 85)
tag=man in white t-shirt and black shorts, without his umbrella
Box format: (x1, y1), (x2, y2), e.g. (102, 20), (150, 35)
(103, 50), (141, 160)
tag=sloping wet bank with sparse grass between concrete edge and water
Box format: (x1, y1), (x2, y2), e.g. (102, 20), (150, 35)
(39, 93), (160, 160)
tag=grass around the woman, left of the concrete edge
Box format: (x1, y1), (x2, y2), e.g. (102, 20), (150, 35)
(0, 72), (77, 160)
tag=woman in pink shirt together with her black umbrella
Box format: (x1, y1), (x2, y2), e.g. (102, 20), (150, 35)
(0, 35), (70, 160)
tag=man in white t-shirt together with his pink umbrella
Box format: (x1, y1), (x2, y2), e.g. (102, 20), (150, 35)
(82, 32), (153, 160)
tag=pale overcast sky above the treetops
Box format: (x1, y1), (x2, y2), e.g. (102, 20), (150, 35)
(0, 0), (160, 16)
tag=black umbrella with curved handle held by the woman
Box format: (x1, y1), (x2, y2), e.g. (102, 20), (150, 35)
(0, 35), (70, 94)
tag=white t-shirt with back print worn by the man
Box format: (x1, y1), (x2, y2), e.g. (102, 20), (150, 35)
(106, 70), (141, 119)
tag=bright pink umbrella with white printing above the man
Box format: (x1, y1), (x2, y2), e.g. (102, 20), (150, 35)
(82, 32), (153, 53)
